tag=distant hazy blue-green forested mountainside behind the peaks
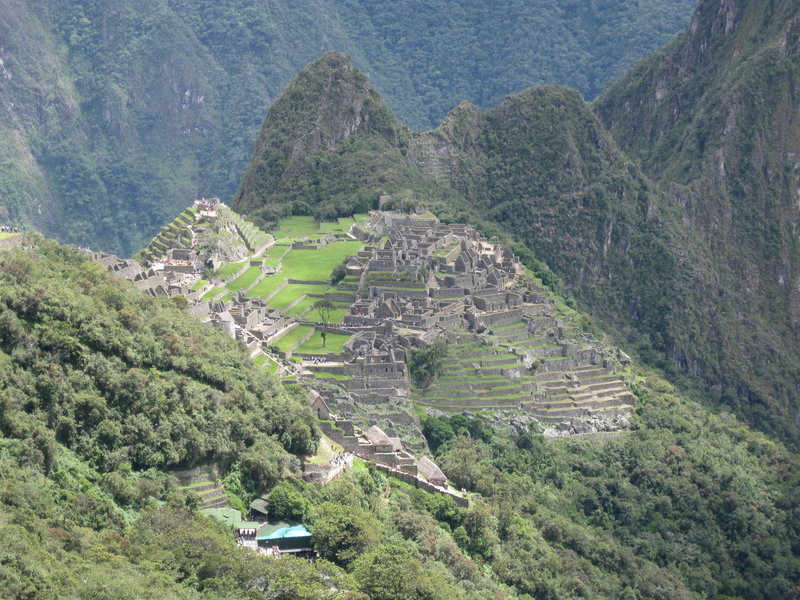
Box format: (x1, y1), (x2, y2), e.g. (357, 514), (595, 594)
(0, 0), (692, 255)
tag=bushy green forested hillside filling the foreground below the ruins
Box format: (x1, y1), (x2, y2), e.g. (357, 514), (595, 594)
(0, 238), (800, 600)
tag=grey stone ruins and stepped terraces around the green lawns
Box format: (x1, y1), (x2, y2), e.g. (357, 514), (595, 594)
(89, 206), (633, 460)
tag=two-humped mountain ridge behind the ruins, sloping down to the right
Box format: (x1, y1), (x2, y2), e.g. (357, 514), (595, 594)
(236, 47), (800, 440)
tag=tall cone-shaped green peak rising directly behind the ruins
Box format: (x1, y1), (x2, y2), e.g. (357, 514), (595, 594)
(232, 52), (450, 222)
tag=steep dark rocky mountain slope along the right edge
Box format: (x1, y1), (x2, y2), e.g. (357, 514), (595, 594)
(595, 0), (800, 440)
